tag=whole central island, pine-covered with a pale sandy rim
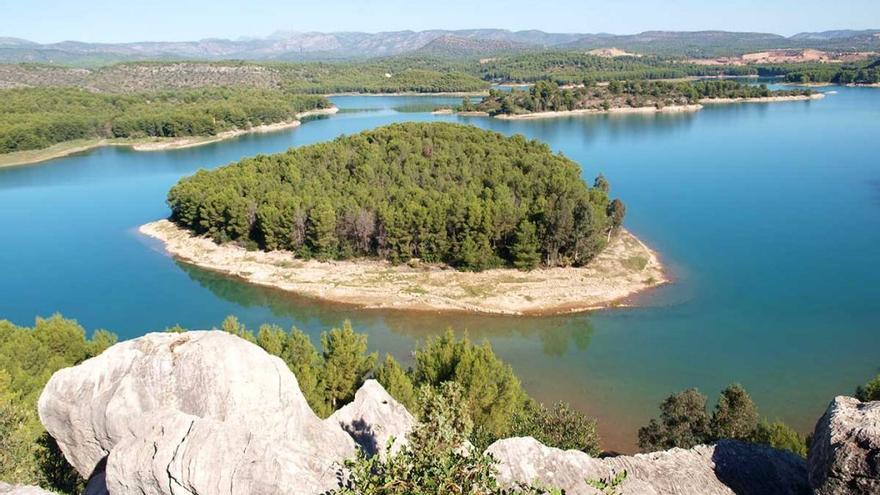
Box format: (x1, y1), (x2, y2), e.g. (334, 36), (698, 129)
(141, 123), (666, 314)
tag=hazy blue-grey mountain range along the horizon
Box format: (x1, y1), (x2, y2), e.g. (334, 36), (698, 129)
(0, 29), (880, 65)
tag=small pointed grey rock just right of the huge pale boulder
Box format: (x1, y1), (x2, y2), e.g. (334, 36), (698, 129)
(327, 380), (416, 455)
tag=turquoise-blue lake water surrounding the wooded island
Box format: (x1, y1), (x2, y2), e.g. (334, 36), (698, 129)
(0, 88), (880, 450)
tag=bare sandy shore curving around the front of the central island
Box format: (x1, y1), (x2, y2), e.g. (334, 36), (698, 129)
(139, 220), (667, 315)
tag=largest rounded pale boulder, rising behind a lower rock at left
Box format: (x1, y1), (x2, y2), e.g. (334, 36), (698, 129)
(38, 331), (354, 479)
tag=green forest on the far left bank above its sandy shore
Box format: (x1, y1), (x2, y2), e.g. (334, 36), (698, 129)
(0, 88), (330, 153)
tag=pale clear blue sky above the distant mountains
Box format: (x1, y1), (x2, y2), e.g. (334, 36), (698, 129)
(0, 0), (880, 43)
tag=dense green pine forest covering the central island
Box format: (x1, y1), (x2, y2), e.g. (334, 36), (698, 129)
(168, 123), (624, 270)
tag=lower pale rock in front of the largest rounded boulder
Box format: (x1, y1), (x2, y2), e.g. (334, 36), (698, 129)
(106, 410), (341, 495)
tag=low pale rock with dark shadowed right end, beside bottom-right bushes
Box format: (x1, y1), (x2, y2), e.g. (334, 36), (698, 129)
(486, 437), (809, 495)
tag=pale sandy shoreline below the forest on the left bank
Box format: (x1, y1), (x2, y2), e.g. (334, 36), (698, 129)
(0, 106), (339, 168)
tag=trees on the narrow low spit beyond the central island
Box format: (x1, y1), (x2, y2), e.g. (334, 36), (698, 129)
(470, 80), (812, 115)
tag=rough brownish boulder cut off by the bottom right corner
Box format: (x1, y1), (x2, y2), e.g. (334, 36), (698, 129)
(809, 397), (880, 495)
